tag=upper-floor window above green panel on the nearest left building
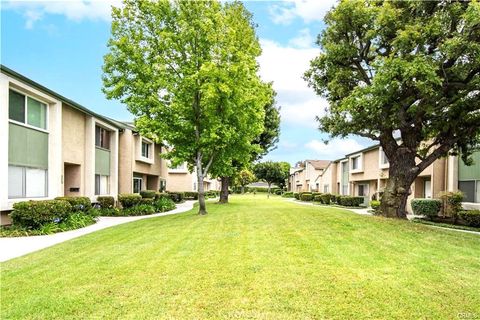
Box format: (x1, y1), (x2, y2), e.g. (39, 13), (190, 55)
(8, 90), (47, 130)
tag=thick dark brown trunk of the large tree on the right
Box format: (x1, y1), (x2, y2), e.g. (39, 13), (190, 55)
(380, 154), (418, 219)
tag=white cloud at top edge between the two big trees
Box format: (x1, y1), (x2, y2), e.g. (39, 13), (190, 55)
(269, 0), (337, 25)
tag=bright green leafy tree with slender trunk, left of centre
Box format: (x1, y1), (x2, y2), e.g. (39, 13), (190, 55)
(103, 0), (271, 214)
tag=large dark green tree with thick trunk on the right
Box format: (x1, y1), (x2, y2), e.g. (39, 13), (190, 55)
(305, 0), (480, 218)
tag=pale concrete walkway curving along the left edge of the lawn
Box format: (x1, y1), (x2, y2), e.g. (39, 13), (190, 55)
(0, 201), (196, 262)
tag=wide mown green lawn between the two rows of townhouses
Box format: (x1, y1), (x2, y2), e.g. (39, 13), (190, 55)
(0, 194), (480, 319)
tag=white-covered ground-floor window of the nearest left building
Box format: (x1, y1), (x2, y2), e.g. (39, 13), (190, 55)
(8, 165), (47, 199)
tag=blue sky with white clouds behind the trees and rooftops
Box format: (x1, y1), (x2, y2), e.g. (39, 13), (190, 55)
(0, 0), (372, 165)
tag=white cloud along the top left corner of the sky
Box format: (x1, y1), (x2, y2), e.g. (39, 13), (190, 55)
(3, 0), (122, 29)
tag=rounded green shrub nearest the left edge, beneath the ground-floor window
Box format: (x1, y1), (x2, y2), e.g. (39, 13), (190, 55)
(10, 200), (72, 229)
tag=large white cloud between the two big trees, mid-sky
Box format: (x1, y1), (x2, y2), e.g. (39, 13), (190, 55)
(258, 39), (328, 128)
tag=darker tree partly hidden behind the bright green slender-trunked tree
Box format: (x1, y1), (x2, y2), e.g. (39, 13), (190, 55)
(219, 90), (280, 203)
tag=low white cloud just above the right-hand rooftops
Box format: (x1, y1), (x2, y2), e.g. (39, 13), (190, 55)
(305, 138), (365, 159)
